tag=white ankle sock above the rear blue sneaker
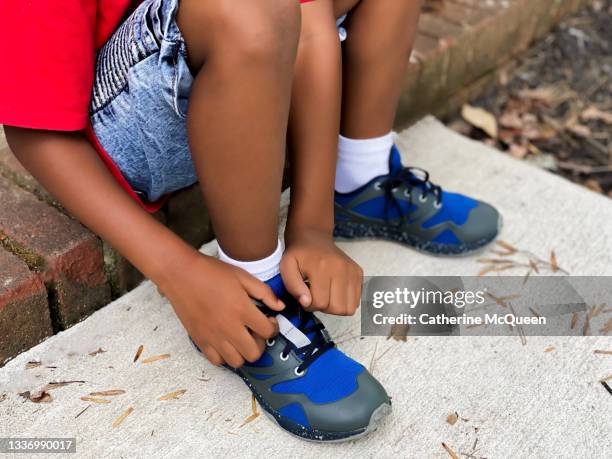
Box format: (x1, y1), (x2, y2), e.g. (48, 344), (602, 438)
(335, 132), (393, 193)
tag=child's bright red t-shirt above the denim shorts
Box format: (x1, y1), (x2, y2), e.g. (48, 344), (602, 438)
(0, 0), (312, 211)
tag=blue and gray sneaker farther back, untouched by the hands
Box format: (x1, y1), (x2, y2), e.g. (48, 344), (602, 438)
(334, 146), (502, 255)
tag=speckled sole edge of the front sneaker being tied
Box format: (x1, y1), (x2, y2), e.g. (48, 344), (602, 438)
(228, 368), (391, 443)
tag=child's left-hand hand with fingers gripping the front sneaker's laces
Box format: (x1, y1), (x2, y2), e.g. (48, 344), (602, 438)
(160, 253), (285, 368)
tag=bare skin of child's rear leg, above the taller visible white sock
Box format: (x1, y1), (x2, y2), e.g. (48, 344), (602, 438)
(336, 0), (421, 139)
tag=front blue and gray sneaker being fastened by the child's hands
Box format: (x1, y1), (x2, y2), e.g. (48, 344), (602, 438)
(194, 276), (391, 442)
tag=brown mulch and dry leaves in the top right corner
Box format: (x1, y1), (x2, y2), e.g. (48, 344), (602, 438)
(449, 0), (612, 197)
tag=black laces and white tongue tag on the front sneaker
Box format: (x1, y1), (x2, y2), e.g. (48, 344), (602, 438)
(259, 305), (336, 376)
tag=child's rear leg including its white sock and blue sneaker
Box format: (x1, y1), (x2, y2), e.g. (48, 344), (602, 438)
(335, 0), (501, 255)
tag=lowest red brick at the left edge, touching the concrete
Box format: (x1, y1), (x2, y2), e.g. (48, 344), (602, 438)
(0, 247), (53, 366)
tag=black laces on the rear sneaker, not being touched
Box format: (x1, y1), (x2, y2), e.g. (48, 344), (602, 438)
(378, 167), (442, 226)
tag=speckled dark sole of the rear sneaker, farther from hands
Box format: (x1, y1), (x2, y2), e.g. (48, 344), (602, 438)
(334, 214), (503, 257)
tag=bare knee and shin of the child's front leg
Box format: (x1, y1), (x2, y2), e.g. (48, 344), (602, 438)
(177, 0), (300, 261)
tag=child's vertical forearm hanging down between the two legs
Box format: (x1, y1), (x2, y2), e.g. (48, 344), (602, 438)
(287, 2), (341, 239)
